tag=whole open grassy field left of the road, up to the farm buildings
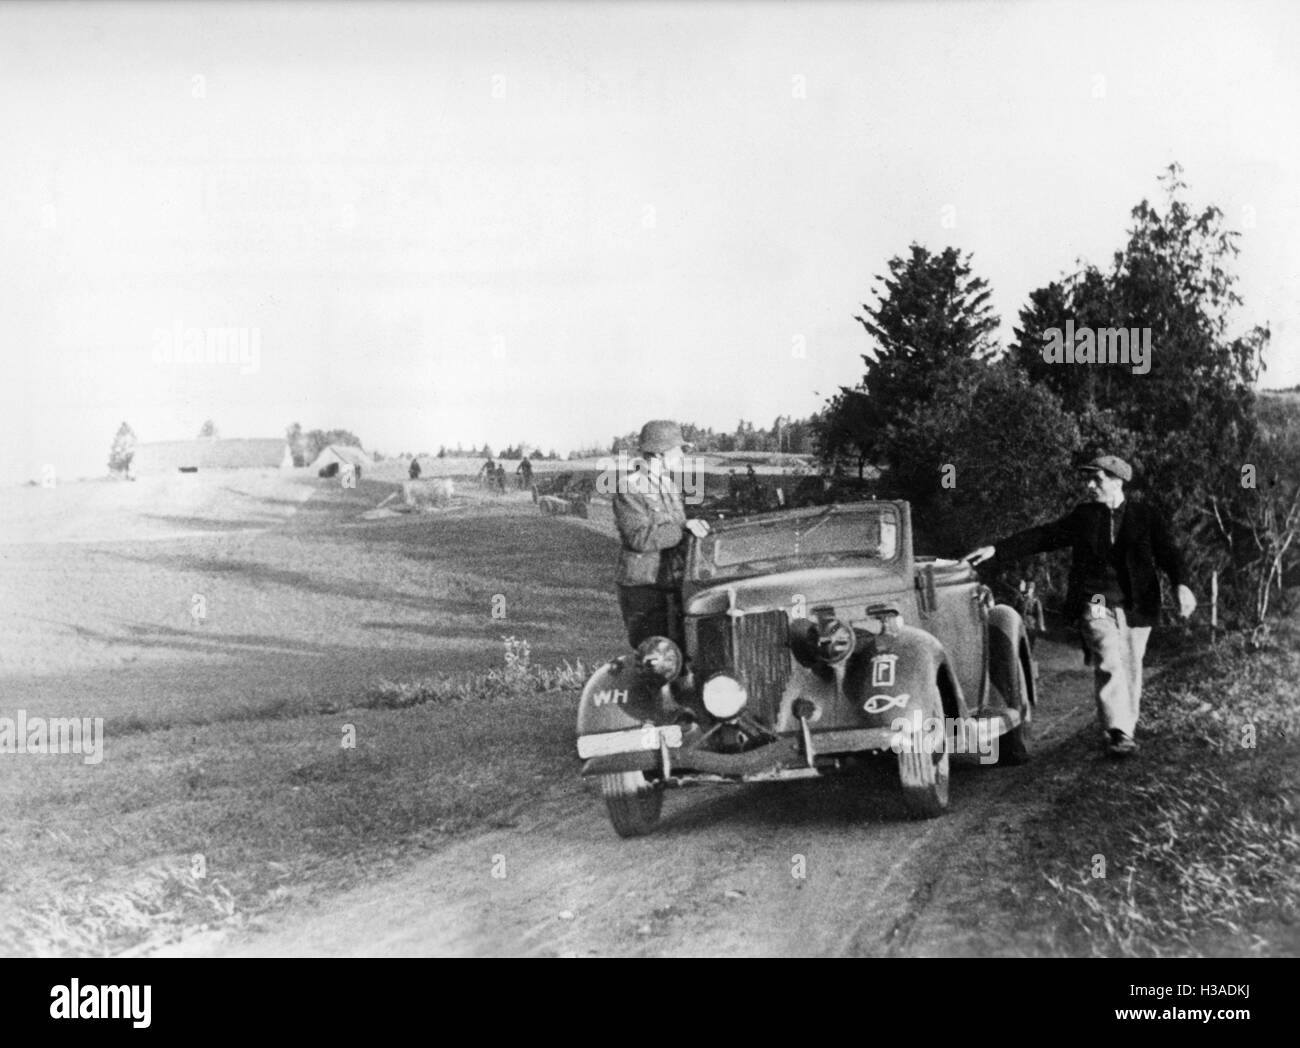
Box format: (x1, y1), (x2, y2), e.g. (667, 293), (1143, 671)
(0, 477), (623, 954)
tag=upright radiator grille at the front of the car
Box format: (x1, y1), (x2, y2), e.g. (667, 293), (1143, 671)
(692, 611), (790, 726)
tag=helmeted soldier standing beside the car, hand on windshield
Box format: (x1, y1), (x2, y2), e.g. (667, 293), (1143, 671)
(614, 419), (709, 648)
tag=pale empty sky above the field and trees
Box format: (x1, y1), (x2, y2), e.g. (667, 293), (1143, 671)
(0, 0), (1300, 480)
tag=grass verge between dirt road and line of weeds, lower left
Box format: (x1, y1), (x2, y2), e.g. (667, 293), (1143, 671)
(0, 638), (586, 957)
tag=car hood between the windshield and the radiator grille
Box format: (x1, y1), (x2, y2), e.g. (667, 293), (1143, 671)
(686, 564), (911, 615)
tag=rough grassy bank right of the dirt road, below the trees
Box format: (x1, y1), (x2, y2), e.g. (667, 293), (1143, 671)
(1005, 619), (1300, 957)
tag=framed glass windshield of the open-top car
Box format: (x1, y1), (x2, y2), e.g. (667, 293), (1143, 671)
(694, 506), (898, 581)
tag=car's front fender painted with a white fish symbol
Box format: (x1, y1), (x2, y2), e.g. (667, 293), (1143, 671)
(844, 625), (966, 727)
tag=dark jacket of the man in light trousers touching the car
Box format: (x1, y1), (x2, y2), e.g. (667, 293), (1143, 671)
(995, 499), (1187, 625)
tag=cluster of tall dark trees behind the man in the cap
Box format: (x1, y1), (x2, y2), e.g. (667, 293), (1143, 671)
(816, 164), (1300, 625)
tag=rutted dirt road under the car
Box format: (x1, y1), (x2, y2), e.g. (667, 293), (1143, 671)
(172, 645), (1092, 957)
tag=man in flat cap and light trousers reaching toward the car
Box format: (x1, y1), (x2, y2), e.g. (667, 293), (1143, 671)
(965, 455), (1196, 757)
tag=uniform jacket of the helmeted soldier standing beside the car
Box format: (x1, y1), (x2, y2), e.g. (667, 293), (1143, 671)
(614, 471), (686, 589)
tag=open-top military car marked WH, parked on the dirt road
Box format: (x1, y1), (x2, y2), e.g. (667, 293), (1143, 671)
(577, 502), (1036, 837)
